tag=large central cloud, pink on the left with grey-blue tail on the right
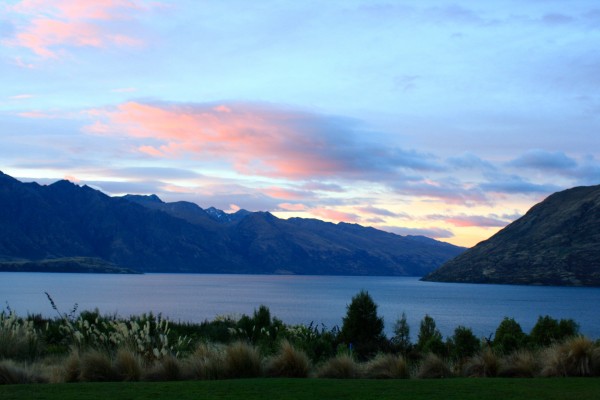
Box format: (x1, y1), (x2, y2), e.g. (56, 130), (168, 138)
(86, 102), (442, 180)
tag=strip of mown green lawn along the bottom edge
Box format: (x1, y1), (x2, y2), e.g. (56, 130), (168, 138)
(0, 378), (600, 400)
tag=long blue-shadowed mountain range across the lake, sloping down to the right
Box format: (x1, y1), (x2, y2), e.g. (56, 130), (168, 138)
(0, 172), (465, 276)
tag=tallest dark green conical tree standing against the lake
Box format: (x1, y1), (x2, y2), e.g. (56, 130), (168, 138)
(340, 290), (385, 359)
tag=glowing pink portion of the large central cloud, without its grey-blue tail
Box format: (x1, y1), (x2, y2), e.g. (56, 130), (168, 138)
(86, 102), (354, 179)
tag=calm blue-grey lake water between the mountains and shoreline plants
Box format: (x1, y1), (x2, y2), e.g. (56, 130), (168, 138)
(0, 273), (600, 338)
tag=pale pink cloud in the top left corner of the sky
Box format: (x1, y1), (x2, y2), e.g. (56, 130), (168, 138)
(5, 0), (151, 58)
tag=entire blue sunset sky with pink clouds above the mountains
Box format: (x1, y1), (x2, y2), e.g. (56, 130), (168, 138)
(0, 0), (600, 246)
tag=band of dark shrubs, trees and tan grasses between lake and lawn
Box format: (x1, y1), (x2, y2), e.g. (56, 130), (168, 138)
(0, 292), (600, 386)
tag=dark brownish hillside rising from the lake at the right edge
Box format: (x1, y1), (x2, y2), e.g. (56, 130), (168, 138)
(423, 185), (600, 286)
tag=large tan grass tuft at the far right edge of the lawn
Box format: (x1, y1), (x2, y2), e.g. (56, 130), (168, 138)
(541, 336), (600, 376)
